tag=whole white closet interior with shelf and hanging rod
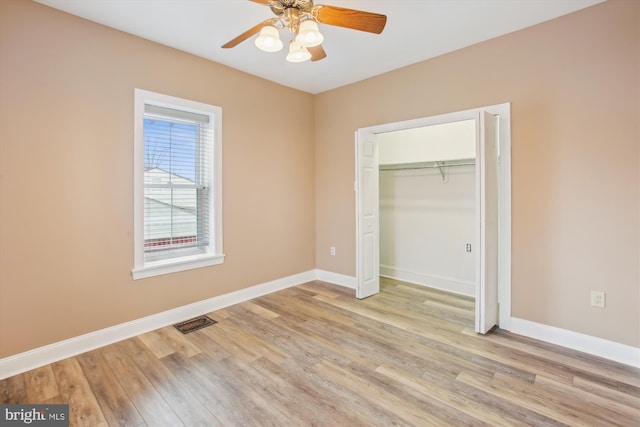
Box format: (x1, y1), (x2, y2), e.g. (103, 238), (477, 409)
(378, 121), (476, 297)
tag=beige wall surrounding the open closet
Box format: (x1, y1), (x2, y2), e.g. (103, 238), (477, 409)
(315, 0), (640, 346)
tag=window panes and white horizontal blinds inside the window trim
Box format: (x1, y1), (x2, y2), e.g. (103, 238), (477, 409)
(144, 104), (211, 261)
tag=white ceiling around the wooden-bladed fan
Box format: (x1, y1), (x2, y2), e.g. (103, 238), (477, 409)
(36, 0), (603, 94)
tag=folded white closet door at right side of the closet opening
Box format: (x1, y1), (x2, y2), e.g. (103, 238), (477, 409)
(475, 111), (498, 334)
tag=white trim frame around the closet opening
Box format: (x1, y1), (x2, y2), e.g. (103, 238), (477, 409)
(354, 102), (511, 330)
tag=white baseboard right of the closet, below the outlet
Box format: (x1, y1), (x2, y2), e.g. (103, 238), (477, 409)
(511, 317), (640, 368)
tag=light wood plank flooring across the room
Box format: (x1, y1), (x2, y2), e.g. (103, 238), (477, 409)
(0, 279), (640, 427)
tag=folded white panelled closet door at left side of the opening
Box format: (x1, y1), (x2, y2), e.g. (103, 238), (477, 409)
(356, 130), (380, 299)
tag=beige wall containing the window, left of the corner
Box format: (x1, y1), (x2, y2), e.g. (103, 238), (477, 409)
(0, 0), (315, 358)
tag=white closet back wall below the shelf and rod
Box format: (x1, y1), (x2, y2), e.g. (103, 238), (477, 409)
(380, 162), (475, 296)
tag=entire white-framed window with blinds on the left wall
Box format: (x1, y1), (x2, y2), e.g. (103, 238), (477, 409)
(132, 89), (224, 279)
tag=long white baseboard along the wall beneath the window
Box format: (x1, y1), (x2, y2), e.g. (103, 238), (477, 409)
(0, 270), (317, 379)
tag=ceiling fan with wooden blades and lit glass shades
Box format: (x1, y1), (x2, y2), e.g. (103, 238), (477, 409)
(222, 0), (387, 62)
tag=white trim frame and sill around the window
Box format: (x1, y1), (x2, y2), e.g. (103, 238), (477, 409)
(131, 89), (224, 280)
